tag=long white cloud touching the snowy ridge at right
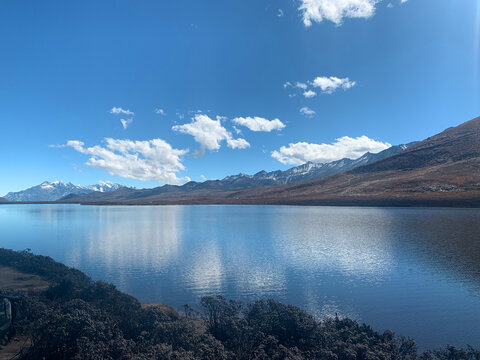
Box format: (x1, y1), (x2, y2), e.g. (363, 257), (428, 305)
(272, 136), (391, 165)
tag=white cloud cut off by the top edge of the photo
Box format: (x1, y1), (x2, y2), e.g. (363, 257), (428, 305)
(299, 0), (379, 27)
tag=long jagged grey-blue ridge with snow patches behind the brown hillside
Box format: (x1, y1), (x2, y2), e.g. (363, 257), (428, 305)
(61, 143), (415, 202)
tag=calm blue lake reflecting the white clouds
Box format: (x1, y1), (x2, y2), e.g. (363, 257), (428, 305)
(0, 205), (480, 349)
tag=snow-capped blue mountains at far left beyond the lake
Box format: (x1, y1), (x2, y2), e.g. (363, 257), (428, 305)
(4, 181), (125, 201)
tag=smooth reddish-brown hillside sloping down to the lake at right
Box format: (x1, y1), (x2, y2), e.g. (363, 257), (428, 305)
(232, 117), (480, 206)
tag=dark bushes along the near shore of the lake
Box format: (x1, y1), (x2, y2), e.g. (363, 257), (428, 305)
(0, 249), (480, 360)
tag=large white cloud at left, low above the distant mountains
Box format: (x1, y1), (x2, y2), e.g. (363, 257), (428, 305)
(62, 138), (190, 184)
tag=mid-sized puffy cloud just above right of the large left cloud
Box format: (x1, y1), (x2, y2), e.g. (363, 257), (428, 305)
(172, 114), (250, 155)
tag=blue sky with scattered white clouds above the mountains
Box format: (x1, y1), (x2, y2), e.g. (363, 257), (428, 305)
(0, 0), (480, 194)
